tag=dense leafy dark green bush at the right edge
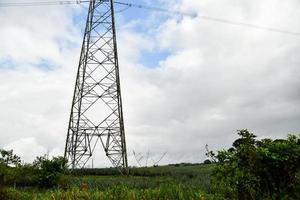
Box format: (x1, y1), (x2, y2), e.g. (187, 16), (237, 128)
(213, 130), (300, 200)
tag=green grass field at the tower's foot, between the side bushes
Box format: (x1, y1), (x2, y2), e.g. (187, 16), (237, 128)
(1, 165), (217, 200)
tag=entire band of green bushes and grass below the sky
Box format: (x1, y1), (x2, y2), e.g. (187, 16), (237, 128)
(0, 130), (300, 200)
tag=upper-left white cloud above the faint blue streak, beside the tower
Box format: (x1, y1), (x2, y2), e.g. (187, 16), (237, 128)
(0, 7), (81, 66)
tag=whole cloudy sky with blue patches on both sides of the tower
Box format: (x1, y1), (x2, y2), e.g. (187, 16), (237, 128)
(0, 0), (300, 167)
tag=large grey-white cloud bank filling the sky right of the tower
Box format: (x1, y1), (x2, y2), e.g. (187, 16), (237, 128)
(124, 0), (300, 162)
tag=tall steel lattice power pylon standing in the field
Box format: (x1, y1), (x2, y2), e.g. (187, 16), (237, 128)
(65, 0), (127, 171)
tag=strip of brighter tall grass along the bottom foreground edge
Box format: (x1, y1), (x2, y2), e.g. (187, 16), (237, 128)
(6, 184), (216, 200)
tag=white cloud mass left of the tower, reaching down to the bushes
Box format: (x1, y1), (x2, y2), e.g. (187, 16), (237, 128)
(0, 7), (81, 161)
